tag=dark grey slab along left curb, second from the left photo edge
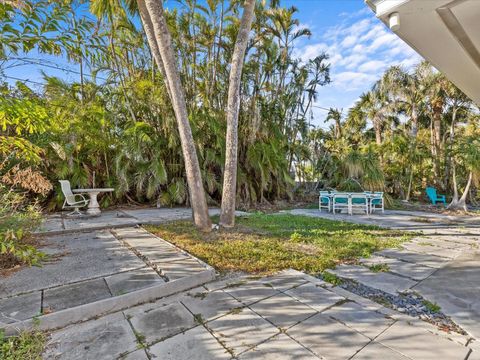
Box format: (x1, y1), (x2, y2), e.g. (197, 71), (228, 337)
(43, 278), (112, 311)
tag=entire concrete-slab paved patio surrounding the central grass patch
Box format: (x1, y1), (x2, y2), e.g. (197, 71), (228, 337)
(0, 209), (480, 360)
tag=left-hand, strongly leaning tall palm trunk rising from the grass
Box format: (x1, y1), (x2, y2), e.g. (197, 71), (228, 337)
(141, 0), (212, 231)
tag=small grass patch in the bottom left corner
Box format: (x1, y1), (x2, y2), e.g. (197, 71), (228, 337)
(0, 330), (47, 360)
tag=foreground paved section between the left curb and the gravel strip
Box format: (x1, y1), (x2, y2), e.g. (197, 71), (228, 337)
(45, 270), (474, 360)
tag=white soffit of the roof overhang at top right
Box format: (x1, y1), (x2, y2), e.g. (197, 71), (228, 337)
(366, 0), (480, 105)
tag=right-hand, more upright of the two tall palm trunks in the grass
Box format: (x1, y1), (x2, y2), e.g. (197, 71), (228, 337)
(220, 0), (256, 227)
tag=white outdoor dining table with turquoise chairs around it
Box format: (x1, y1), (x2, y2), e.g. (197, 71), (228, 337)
(318, 190), (385, 215)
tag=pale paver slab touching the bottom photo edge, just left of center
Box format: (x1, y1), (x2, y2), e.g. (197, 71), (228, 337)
(149, 326), (232, 360)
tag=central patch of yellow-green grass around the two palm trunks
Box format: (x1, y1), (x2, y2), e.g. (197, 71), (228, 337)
(146, 214), (411, 274)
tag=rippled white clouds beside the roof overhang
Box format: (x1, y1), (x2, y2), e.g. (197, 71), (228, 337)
(295, 9), (421, 115)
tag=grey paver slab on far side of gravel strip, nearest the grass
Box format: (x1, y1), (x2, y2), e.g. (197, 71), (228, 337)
(328, 265), (417, 295)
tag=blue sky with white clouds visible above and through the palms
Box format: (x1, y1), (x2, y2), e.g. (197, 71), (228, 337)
(6, 0), (421, 127)
